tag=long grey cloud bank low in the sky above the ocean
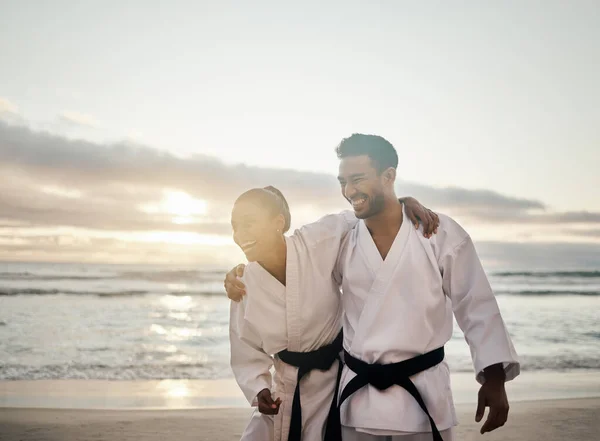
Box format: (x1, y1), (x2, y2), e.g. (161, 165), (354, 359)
(0, 122), (600, 239)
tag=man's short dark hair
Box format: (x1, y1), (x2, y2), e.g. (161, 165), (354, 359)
(335, 133), (398, 173)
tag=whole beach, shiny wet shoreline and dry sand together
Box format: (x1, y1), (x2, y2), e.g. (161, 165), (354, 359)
(0, 371), (600, 441)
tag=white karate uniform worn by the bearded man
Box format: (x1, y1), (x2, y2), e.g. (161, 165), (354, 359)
(336, 205), (519, 440)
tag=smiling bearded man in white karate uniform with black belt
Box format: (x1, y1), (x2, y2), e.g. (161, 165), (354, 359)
(230, 134), (519, 441)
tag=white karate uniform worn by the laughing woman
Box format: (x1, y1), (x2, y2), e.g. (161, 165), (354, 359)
(230, 211), (357, 441)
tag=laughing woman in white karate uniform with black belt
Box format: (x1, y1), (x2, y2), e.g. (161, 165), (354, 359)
(230, 187), (437, 441)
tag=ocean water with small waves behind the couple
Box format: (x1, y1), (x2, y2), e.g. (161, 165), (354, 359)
(0, 263), (600, 380)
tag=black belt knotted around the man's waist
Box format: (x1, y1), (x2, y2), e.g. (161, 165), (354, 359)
(339, 346), (444, 441)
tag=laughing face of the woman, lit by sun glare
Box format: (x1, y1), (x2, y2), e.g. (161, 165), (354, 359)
(231, 199), (283, 262)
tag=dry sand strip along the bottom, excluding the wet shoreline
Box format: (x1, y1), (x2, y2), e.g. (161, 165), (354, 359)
(0, 398), (600, 441)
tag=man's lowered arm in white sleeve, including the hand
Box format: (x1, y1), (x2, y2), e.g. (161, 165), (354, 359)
(440, 235), (520, 433)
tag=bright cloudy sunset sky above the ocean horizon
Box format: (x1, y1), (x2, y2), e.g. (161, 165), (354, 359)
(0, 0), (600, 264)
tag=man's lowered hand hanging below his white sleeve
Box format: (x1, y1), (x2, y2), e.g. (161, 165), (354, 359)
(475, 363), (509, 434)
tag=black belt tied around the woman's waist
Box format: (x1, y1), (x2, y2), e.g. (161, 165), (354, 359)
(277, 332), (343, 441)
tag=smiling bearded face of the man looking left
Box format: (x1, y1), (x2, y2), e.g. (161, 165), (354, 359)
(338, 155), (385, 219)
